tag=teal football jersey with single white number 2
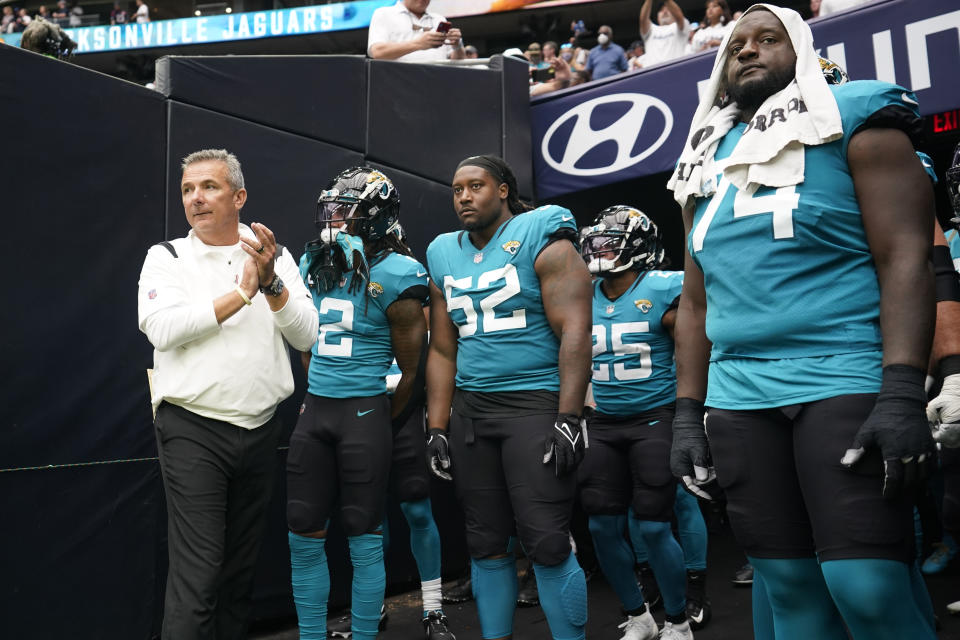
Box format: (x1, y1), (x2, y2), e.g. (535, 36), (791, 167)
(300, 253), (427, 398)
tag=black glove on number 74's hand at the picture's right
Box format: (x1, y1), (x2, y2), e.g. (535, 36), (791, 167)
(840, 364), (936, 499)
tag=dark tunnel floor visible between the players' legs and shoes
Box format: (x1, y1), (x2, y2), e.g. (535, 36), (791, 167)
(250, 529), (960, 640)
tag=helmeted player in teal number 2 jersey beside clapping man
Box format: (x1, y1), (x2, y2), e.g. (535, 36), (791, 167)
(287, 167), (428, 640)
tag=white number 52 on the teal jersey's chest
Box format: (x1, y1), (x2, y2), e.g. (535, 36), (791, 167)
(443, 264), (527, 338)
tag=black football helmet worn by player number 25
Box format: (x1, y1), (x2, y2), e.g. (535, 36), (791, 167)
(580, 205), (664, 275)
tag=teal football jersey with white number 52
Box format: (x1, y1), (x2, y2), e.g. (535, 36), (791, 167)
(427, 205), (577, 392)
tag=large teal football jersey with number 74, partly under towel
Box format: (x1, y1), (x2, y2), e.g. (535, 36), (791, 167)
(687, 80), (919, 409)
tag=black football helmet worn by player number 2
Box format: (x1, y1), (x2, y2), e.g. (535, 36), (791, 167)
(316, 167), (400, 240)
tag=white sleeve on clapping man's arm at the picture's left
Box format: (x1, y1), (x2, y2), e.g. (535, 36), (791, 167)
(137, 245), (220, 351)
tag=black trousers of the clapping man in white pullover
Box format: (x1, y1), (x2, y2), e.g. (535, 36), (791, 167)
(154, 403), (281, 640)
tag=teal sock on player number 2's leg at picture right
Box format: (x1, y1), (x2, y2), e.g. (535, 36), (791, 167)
(347, 533), (387, 640)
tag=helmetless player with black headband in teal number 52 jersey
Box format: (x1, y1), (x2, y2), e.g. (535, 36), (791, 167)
(427, 156), (590, 640)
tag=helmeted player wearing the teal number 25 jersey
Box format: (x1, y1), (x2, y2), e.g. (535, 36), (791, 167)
(577, 205), (693, 640)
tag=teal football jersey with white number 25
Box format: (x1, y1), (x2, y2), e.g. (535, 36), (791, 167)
(593, 271), (683, 416)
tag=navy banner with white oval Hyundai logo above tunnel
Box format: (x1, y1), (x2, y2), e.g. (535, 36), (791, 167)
(531, 0), (960, 198)
